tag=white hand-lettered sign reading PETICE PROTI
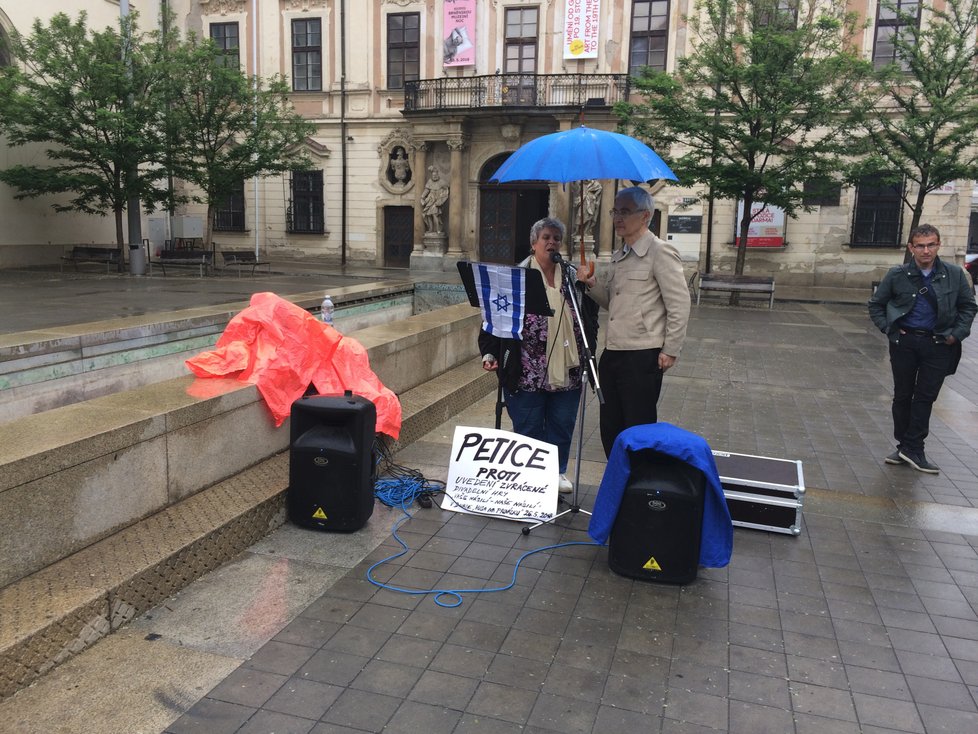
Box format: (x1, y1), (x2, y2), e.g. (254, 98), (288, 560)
(441, 426), (558, 522)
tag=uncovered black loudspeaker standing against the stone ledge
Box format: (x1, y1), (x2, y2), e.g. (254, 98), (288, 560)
(286, 391), (377, 532)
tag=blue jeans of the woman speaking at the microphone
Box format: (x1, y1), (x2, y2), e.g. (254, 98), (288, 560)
(503, 388), (581, 474)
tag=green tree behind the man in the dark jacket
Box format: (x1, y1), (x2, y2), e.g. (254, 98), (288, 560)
(858, 0), (978, 240)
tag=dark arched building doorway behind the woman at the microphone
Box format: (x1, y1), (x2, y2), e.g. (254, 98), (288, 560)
(479, 153), (550, 265)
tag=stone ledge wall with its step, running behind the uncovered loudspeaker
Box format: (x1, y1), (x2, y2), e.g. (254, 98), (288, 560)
(0, 304), (495, 698)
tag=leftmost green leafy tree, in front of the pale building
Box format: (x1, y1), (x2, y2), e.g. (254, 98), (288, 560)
(0, 12), (165, 261)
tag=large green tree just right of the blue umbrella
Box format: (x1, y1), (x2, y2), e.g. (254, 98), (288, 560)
(618, 0), (871, 282)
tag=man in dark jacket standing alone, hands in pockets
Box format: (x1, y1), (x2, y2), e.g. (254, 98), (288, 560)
(868, 224), (978, 474)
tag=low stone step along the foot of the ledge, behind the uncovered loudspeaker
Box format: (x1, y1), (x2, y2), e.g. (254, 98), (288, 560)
(0, 361), (496, 699)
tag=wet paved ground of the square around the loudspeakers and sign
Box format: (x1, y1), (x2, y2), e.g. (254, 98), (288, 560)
(0, 264), (978, 734)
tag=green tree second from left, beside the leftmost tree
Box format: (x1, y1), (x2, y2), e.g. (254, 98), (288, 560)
(168, 36), (315, 246)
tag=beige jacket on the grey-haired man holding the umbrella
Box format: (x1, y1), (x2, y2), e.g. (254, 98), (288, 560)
(588, 232), (690, 357)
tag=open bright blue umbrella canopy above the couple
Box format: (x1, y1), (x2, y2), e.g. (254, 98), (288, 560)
(489, 125), (678, 183)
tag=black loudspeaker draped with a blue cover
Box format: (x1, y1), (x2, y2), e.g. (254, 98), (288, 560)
(608, 449), (706, 584)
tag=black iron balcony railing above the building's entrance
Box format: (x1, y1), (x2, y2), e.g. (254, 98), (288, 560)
(404, 74), (630, 113)
